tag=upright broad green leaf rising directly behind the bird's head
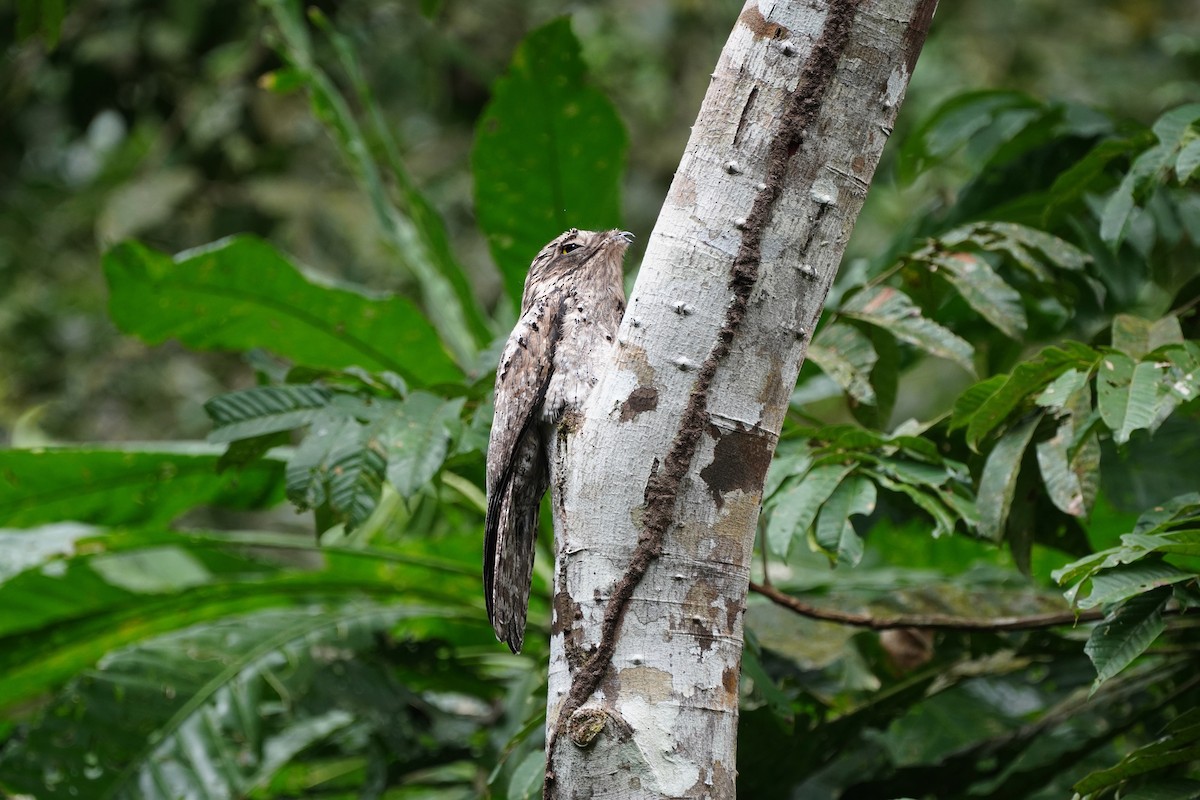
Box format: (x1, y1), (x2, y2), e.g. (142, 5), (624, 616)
(470, 18), (626, 302)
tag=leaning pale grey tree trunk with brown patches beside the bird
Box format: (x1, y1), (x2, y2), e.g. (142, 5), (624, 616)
(545, 0), (936, 799)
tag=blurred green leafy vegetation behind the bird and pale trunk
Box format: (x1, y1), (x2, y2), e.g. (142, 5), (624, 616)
(0, 0), (1200, 799)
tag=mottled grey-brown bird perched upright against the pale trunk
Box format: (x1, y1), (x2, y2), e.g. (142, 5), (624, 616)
(484, 228), (634, 652)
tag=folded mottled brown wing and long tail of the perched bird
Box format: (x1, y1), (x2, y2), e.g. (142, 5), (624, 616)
(484, 300), (562, 652)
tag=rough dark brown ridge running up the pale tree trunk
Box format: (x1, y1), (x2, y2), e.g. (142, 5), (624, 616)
(542, 0), (859, 798)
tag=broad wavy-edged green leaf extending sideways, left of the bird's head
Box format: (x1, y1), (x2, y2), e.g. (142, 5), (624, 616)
(104, 236), (463, 386)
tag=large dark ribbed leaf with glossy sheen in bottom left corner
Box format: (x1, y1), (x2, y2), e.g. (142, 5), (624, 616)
(2, 601), (470, 800)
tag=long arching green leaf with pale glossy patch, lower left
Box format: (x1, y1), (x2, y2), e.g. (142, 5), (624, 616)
(0, 529), (477, 712)
